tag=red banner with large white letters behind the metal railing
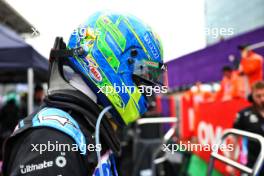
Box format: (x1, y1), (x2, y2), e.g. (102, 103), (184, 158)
(194, 99), (249, 173)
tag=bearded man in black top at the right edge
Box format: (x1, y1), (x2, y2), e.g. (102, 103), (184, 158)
(234, 81), (264, 175)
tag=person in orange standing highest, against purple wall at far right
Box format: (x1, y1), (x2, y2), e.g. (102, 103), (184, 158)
(239, 46), (263, 89)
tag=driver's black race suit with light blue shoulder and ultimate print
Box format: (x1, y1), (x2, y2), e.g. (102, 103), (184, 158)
(3, 90), (119, 176)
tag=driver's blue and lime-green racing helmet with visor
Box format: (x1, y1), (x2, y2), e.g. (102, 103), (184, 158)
(67, 12), (163, 125)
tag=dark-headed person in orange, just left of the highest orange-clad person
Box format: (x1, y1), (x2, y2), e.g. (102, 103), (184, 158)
(216, 66), (241, 101)
